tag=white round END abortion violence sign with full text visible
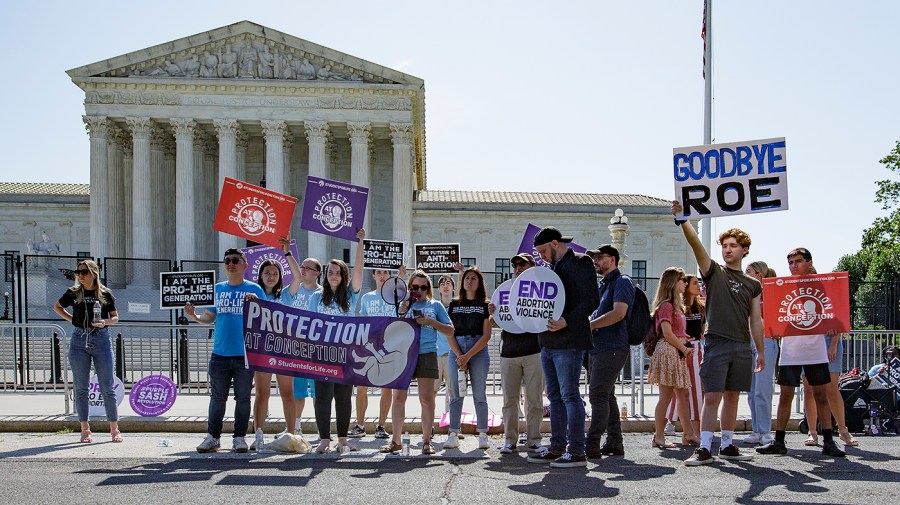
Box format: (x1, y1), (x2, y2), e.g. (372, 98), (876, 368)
(509, 268), (566, 333)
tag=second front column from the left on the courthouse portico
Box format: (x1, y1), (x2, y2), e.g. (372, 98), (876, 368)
(125, 117), (153, 258)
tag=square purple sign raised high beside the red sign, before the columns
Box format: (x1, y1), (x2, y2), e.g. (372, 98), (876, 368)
(300, 176), (369, 242)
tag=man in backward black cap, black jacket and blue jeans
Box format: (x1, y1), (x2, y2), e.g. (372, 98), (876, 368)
(528, 226), (600, 468)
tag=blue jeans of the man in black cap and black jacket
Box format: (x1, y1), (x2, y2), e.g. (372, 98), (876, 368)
(541, 347), (584, 456)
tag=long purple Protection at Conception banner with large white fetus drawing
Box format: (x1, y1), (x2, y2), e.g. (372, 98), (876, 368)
(244, 299), (421, 389)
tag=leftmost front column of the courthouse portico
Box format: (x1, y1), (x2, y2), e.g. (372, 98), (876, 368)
(82, 116), (109, 258)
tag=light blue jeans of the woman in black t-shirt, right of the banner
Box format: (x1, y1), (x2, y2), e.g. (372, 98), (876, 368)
(447, 335), (491, 433)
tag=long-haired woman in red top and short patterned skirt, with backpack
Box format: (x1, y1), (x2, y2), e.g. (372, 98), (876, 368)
(648, 267), (700, 449)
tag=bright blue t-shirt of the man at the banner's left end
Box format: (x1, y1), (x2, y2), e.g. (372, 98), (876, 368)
(207, 280), (266, 356)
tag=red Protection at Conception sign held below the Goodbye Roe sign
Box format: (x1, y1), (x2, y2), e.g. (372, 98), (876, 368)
(763, 272), (850, 337)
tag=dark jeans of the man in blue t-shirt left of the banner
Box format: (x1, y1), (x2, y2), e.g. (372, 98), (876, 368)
(206, 354), (253, 438)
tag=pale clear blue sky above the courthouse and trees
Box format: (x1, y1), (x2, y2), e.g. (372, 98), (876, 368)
(0, 0), (900, 273)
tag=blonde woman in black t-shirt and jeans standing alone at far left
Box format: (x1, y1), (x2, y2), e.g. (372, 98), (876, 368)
(53, 260), (122, 444)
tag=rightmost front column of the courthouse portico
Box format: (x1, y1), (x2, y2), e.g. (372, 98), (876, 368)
(390, 123), (413, 250)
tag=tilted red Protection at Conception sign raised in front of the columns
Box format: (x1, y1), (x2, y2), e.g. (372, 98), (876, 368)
(213, 177), (297, 247)
